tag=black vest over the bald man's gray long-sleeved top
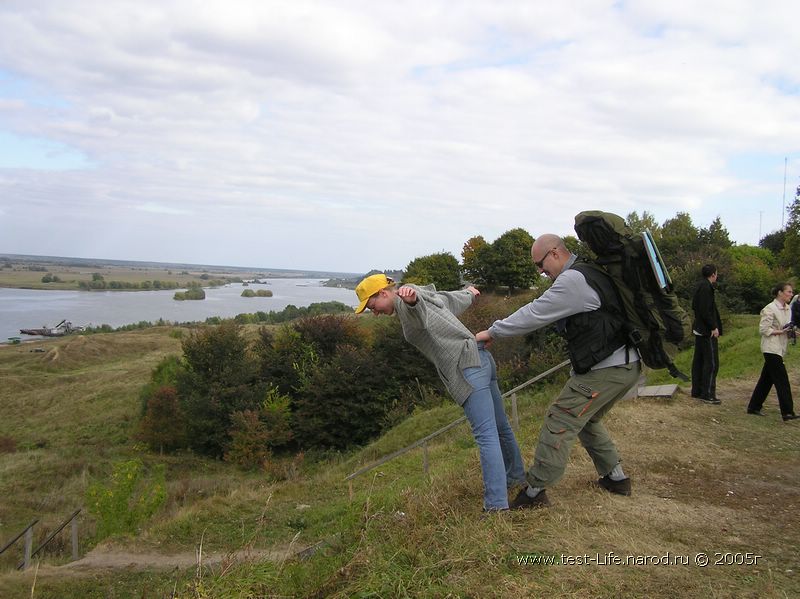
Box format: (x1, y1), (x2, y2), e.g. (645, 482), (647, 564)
(556, 260), (627, 374)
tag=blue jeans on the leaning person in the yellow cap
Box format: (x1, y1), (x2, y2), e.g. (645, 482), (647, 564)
(463, 344), (525, 510)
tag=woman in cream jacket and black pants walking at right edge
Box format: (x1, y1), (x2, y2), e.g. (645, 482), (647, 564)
(747, 283), (798, 422)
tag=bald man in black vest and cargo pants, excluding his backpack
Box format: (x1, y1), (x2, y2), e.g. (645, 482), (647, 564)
(476, 233), (641, 509)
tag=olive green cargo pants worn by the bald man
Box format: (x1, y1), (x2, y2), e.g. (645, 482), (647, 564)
(527, 362), (641, 488)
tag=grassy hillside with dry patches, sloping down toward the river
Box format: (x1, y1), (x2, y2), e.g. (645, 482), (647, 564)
(0, 317), (800, 599)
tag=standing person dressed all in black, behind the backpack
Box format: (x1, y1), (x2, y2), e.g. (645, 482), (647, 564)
(692, 264), (722, 404)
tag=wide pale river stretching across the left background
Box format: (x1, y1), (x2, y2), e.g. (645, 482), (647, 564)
(0, 279), (358, 343)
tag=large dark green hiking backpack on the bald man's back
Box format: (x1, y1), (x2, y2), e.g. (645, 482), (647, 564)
(575, 210), (689, 381)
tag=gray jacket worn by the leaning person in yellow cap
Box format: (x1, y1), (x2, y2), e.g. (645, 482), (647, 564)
(394, 285), (481, 405)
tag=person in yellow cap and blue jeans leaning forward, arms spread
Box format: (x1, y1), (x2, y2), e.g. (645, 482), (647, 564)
(356, 274), (525, 512)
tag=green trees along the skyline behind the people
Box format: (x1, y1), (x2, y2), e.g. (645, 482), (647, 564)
(400, 193), (800, 313)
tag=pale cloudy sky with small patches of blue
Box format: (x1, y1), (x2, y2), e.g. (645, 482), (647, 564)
(0, 0), (800, 273)
